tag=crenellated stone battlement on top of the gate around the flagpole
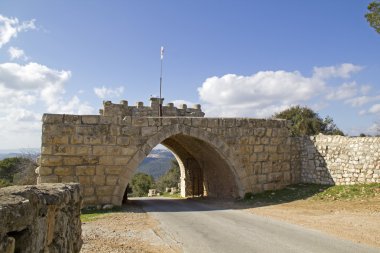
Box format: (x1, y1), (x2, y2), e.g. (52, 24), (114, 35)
(99, 97), (205, 117)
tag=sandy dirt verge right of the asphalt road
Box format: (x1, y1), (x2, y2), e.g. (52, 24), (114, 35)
(247, 199), (380, 248)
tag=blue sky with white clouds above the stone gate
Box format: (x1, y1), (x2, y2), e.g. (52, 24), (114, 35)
(0, 0), (380, 149)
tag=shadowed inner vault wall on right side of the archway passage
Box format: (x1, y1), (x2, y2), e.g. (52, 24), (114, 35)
(123, 133), (239, 201)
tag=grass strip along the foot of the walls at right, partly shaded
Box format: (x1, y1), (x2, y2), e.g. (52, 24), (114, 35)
(243, 183), (380, 204)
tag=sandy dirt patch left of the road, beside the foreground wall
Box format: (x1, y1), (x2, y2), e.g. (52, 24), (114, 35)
(81, 205), (181, 253)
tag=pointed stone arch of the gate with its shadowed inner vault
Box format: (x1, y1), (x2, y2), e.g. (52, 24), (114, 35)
(113, 125), (244, 204)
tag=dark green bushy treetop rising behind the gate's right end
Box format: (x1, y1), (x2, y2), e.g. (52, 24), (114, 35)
(273, 105), (344, 136)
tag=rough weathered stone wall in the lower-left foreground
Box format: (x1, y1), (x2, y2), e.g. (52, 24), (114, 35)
(0, 184), (82, 253)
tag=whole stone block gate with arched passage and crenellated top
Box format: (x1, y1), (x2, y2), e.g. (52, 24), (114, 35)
(37, 98), (301, 205)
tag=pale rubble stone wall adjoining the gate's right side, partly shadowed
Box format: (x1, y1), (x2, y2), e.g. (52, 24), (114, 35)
(299, 134), (380, 185)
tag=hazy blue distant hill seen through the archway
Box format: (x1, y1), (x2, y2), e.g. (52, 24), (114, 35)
(137, 149), (175, 179)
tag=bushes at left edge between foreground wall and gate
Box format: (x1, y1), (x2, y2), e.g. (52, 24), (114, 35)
(0, 155), (37, 187)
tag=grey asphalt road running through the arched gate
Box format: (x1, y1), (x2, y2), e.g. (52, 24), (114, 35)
(135, 198), (380, 253)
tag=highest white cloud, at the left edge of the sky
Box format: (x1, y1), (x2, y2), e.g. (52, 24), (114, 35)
(0, 15), (36, 48)
